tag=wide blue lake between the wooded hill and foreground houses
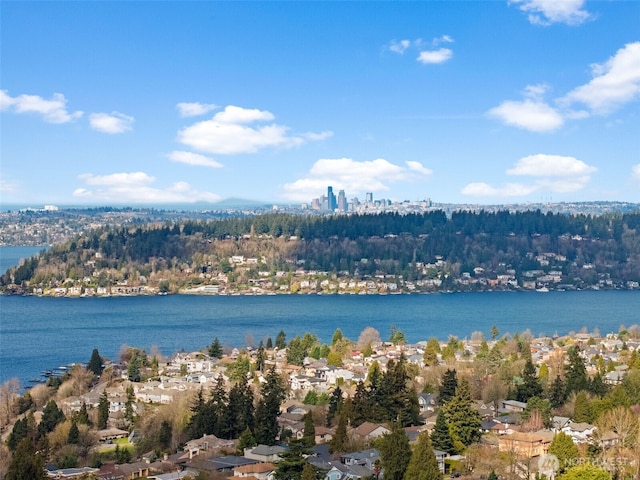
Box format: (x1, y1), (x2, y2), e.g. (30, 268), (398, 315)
(0, 291), (640, 386)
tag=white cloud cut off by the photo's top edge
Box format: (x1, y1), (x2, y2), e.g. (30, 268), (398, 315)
(509, 0), (591, 26)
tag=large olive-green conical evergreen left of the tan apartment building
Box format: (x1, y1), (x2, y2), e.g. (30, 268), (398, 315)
(443, 380), (482, 449)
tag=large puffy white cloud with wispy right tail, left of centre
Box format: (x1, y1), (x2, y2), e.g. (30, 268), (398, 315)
(178, 105), (331, 155)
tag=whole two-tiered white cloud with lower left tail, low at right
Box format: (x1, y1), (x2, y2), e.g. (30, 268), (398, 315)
(461, 154), (597, 197)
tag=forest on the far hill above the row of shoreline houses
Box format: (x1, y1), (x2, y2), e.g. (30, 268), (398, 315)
(0, 210), (640, 288)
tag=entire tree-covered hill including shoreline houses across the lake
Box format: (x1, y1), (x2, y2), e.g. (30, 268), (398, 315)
(0, 211), (640, 295)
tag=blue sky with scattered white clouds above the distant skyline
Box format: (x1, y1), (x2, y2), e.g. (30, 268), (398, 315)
(0, 0), (640, 206)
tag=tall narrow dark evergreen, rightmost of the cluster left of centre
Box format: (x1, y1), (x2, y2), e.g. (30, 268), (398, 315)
(255, 368), (285, 445)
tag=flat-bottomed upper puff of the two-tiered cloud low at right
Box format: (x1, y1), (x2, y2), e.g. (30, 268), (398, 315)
(507, 153), (598, 177)
